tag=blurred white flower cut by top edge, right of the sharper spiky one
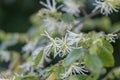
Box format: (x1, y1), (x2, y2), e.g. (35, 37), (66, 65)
(62, 0), (80, 16)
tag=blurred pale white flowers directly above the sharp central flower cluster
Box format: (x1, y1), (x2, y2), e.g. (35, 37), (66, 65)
(43, 16), (72, 33)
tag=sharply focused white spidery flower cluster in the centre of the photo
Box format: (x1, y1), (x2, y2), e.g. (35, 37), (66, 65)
(40, 31), (89, 57)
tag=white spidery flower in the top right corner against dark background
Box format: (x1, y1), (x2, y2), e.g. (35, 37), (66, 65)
(93, 0), (118, 16)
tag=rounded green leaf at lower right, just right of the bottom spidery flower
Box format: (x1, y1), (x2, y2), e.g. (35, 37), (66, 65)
(85, 55), (103, 73)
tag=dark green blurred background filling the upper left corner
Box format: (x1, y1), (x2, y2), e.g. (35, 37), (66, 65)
(0, 0), (40, 33)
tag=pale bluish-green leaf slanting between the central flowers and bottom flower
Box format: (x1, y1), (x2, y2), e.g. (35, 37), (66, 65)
(65, 49), (84, 66)
